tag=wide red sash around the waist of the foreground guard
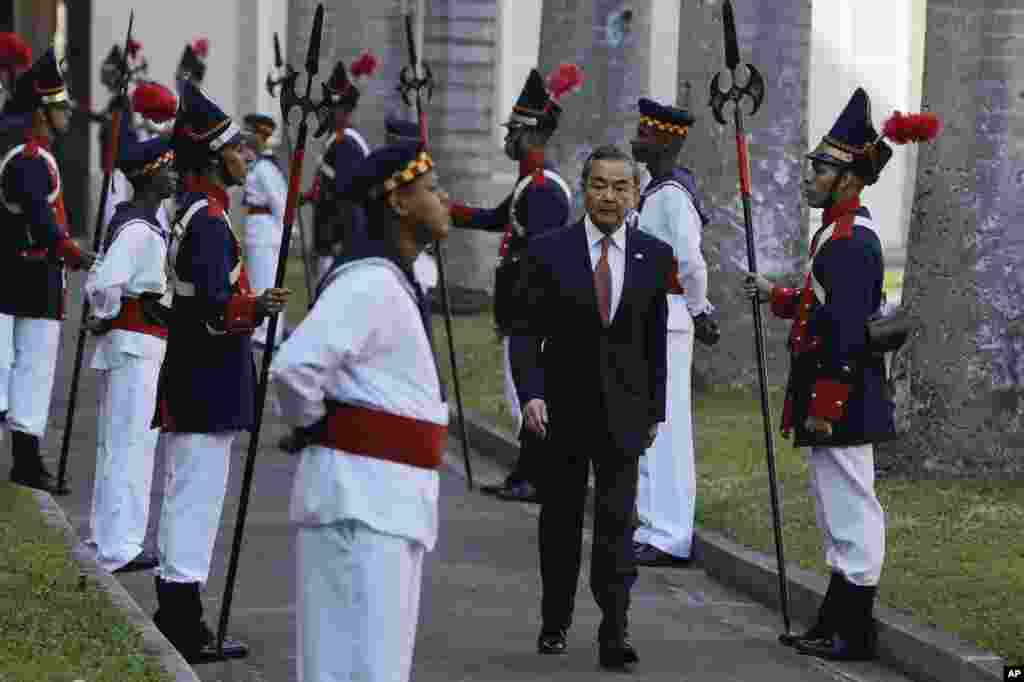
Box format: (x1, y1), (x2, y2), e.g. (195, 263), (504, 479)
(314, 402), (447, 469)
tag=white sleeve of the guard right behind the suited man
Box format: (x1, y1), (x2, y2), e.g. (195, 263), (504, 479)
(644, 187), (715, 316)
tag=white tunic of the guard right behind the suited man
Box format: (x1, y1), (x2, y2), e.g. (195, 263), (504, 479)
(640, 179), (714, 331)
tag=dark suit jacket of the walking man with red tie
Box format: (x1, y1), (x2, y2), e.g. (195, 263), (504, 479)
(511, 220), (673, 455)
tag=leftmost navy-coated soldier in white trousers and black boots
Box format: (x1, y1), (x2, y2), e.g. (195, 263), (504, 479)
(0, 47), (94, 492)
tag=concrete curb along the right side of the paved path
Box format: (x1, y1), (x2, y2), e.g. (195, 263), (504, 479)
(450, 411), (1005, 682)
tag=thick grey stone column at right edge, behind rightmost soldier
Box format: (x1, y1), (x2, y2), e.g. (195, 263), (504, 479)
(879, 0), (1024, 476)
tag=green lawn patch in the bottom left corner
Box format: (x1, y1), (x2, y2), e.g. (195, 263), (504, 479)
(0, 482), (170, 682)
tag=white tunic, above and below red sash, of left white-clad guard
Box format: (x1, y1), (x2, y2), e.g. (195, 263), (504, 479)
(85, 219), (167, 370)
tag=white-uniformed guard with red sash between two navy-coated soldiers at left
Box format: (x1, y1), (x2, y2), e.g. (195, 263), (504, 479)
(85, 130), (178, 572)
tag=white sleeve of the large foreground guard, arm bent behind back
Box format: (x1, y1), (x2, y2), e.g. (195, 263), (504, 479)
(270, 266), (397, 426)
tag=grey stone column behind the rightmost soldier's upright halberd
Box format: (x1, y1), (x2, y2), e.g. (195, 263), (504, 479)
(679, 0), (811, 387)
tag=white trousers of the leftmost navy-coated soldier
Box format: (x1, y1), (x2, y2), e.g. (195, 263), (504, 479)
(7, 317), (60, 438)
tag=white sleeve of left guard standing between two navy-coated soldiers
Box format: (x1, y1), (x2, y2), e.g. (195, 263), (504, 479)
(85, 223), (166, 319)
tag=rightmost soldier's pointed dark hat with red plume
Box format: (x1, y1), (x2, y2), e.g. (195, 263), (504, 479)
(807, 88), (942, 184)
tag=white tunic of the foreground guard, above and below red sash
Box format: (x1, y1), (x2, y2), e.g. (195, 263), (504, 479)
(270, 258), (449, 550)
